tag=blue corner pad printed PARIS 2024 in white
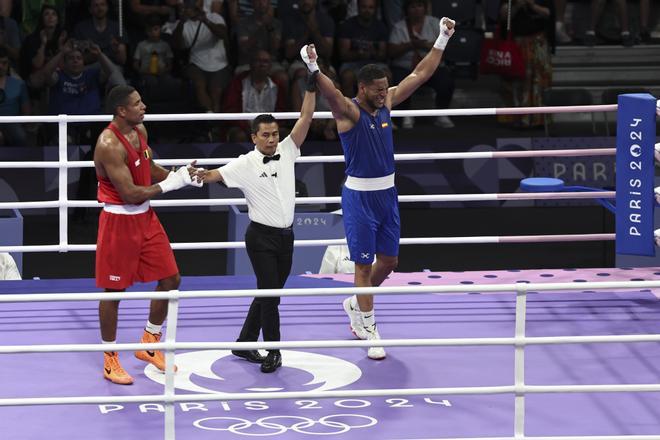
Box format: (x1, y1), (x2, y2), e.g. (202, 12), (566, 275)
(616, 93), (656, 256)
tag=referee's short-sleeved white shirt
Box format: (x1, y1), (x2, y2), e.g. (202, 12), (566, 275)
(218, 136), (300, 228)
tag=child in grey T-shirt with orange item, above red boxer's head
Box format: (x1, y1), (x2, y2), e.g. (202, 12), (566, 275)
(133, 15), (180, 101)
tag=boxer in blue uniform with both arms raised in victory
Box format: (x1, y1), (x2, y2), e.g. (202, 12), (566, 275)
(300, 17), (455, 359)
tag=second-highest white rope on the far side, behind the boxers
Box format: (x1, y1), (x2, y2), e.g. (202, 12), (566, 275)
(0, 148), (616, 168)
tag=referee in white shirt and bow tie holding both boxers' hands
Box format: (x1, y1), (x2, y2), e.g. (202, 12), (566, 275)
(195, 67), (318, 373)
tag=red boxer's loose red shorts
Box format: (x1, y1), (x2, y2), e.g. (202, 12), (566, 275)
(96, 208), (179, 290)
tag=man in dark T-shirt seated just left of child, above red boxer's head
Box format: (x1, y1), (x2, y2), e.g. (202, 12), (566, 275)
(73, 0), (126, 67)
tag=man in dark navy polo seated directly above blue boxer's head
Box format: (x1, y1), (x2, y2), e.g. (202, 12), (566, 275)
(337, 0), (388, 96)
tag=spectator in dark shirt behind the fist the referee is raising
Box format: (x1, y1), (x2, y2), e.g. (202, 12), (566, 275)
(283, 0), (335, 81)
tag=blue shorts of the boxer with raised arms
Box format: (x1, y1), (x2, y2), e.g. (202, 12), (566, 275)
(341, 187), (401, 264)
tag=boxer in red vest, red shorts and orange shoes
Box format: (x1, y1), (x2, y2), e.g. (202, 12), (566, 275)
(94, 86), (201, 385)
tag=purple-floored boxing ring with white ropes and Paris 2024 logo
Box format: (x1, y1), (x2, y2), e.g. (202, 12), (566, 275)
(0, 98), (660, 439)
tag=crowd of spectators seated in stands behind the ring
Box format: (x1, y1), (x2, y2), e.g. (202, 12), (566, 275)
(0, 0), (650, 145)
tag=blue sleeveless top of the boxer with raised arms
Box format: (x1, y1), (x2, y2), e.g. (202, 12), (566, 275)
(339, 98), (394, 178)
